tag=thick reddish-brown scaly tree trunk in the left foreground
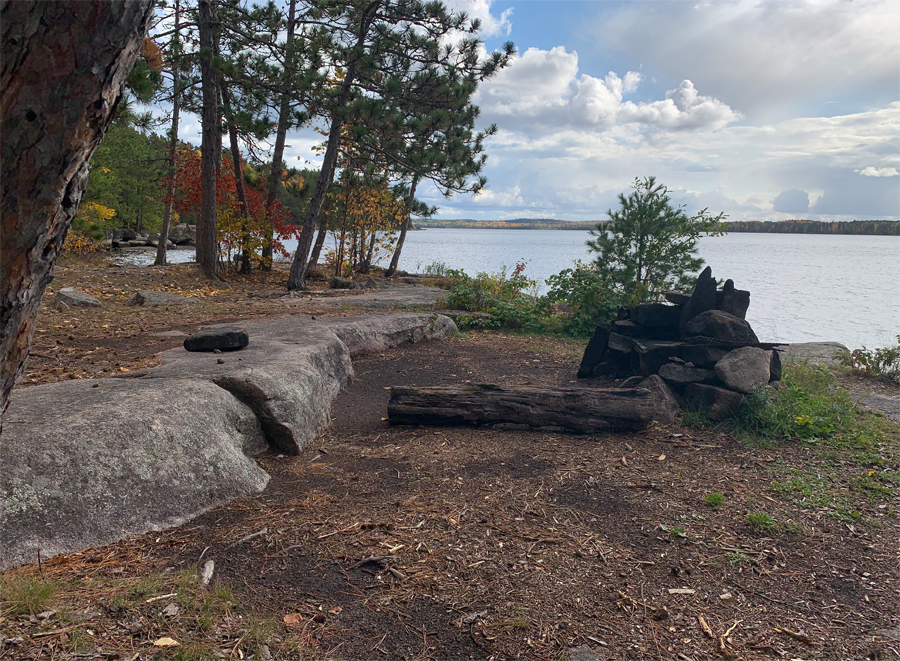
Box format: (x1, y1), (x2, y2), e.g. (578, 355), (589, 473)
(0, 0), (153, 414)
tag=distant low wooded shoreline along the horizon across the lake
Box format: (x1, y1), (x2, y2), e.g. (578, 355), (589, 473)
(413, 218), (900, 236)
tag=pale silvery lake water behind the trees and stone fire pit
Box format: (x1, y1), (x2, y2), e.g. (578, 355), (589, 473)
(121, 229), (900, 348)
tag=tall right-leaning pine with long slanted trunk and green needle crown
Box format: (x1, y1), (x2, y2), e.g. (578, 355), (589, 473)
(288, 0), (513, 289)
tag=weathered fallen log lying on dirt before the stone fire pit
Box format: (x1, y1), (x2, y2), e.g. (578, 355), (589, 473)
(388, 376), (678, 434)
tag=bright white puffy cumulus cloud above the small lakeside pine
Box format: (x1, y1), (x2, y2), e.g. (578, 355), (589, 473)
(478, 46), (740, 132)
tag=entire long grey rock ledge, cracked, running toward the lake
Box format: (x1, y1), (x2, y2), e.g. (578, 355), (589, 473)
(0, 313), (456, 570)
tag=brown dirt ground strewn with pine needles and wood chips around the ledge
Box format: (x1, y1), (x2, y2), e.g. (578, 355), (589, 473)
(0, 258), (900, 661)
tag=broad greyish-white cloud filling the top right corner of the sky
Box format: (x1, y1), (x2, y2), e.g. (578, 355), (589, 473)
(595, 0), (900, 121)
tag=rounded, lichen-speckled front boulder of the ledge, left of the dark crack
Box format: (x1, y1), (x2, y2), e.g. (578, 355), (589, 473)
(0, 379), (269, 569)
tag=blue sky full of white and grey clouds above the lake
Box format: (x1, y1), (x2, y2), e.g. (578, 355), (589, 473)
(178, 0), (900, 220)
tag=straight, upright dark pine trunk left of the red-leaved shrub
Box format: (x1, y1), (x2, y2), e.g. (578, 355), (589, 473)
(197, 0), (219, 278)
